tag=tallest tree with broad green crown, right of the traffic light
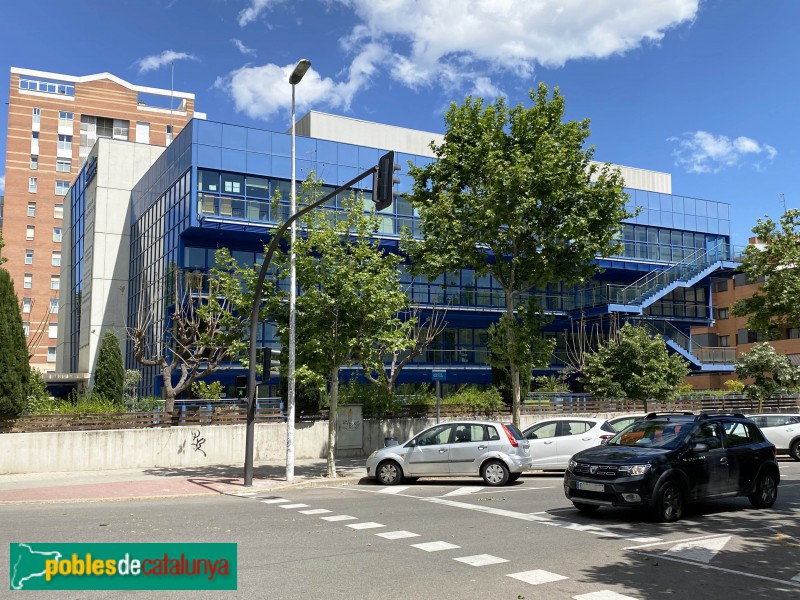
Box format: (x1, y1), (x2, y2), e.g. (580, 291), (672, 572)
(404, 84), (631, 423)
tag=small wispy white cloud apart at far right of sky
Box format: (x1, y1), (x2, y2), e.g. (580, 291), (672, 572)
(667, 131), (778, 173)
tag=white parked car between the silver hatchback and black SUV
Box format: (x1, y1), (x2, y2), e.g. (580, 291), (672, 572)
(522, 417), (616, 470)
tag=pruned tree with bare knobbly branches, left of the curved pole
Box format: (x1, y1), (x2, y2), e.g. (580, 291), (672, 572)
(128, 248), (273, 412)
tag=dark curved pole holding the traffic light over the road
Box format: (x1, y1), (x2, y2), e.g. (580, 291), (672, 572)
(244, 165), (382, 487)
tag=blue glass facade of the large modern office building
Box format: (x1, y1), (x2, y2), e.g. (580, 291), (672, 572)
(127, 119), (730, 393)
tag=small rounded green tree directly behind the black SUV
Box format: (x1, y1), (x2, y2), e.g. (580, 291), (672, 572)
(583, 323), (689, 411)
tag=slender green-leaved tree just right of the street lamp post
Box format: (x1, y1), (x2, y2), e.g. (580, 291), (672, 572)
(279, 195), (408, 477)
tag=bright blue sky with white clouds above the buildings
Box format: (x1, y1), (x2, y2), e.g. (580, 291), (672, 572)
(0, 0), (800, 244)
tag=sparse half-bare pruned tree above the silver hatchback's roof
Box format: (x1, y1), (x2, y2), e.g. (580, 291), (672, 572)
(362, 305), (447, 392)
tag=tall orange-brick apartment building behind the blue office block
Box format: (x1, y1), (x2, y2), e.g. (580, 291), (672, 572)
(2, 67), (199, 371)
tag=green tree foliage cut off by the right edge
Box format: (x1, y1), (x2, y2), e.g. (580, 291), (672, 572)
(732, 208), (800, 337)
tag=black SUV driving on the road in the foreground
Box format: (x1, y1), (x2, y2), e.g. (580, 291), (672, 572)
(564, 413), (780, 521)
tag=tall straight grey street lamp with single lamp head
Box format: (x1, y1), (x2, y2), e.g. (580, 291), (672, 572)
(286, 58), (311, 482)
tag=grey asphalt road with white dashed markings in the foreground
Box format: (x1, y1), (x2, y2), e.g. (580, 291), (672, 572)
(0, 459), (800, 600)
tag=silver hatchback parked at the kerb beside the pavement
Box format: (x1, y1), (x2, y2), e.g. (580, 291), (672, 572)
(367, 421), (531, 486)
